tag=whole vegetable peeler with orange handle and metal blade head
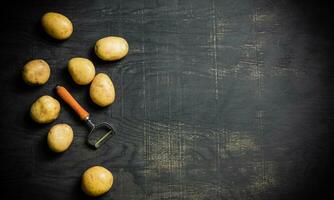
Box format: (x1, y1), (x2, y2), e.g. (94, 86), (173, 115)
(56, 85), (116, 149)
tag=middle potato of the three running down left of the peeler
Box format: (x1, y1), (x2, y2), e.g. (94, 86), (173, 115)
(30, 95), (60, 124)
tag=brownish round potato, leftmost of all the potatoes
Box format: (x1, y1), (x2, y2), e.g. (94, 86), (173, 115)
(22, 59), (50, 85)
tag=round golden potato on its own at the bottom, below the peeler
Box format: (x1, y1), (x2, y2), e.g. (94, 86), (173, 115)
(81, 166), (113, 197)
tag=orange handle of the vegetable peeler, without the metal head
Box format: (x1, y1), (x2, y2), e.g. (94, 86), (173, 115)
(56, 85), (89, 120)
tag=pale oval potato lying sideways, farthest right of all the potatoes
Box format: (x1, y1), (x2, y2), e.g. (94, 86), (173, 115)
(95, 36), (129, 61)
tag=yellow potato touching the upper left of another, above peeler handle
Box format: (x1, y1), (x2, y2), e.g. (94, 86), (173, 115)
(68, 58), (95, 85)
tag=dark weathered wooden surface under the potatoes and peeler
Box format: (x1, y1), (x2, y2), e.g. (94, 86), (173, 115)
(0, 0), (334, 200)
